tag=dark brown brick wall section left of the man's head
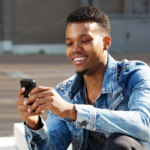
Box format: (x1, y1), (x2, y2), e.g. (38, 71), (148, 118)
(13, 0), (79, 44)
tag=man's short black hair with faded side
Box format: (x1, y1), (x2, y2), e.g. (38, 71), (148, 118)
(66, 6), (110, 35)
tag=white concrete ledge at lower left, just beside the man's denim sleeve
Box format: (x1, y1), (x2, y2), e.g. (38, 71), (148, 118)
(14, 123), (72, 150)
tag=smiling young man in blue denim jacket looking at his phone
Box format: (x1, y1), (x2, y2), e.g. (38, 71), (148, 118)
(16, 6), (150, 150)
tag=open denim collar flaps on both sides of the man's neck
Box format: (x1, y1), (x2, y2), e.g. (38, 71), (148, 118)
(68, 54), (117, 96)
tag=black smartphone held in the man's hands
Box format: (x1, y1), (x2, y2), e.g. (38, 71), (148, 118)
(20, 79), (36, 97)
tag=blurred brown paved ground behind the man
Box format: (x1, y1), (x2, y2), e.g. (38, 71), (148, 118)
(0, 53), (150, 137)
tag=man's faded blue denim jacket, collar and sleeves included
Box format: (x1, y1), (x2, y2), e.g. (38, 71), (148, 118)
(25, 54), (150, 150)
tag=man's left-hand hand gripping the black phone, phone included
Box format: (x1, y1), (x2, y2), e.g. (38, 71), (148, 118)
(16, 79), (44, 130)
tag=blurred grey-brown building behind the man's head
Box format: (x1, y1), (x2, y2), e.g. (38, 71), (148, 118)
(0, 0), (150, 54)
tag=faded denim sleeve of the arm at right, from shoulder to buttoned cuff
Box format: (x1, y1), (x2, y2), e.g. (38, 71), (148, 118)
(75, 61), (150, 141)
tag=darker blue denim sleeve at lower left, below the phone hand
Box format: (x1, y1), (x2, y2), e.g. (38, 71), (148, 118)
(24, 86), (71, 150)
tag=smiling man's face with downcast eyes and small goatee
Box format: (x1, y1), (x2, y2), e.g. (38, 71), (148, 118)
(66, 21), (107, 74)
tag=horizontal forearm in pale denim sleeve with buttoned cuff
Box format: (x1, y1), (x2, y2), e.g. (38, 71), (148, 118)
(76, 105), (149, 141)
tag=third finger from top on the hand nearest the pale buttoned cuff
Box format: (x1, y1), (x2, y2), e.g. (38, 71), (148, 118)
(29, 97), (51, 112)
